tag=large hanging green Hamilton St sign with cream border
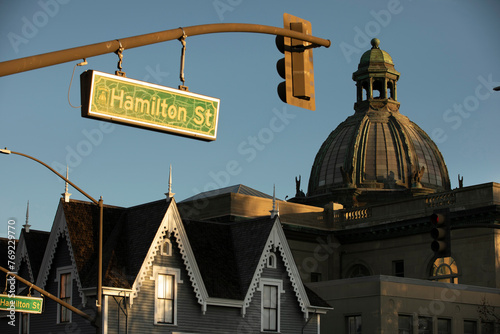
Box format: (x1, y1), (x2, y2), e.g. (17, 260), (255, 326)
(80, 70), (220, 141)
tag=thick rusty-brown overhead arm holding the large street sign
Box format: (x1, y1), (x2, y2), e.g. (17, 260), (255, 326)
(0, 23), (331, 77)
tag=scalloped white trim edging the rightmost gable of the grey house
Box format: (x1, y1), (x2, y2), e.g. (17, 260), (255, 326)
(241, 217), (310, 319)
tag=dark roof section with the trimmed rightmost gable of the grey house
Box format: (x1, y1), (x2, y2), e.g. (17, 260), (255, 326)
(183, 216), (331, 318)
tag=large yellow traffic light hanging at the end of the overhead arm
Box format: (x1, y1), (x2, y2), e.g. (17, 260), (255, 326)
(276, 13), (316, 110)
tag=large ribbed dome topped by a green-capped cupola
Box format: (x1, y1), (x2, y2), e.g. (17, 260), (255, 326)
(304, 38), (450, 207)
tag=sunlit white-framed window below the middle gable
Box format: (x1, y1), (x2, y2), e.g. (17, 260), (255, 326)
(150, 266), (182, 325)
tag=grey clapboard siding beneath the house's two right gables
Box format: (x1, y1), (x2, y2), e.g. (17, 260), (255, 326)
(113, 238), (317, 334)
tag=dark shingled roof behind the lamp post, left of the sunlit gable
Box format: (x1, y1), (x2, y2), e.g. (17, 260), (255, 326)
(63, 200), (168, 288)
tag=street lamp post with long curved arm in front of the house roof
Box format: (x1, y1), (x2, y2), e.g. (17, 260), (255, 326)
(0, 148), (104, 333)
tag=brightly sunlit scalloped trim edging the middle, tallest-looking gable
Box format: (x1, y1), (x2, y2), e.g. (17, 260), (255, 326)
(130, 198), (208, 312)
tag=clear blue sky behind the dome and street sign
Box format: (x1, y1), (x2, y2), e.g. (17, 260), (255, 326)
(0, 0), (500, 237)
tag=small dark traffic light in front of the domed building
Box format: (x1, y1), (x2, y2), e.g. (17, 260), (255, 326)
(430, 210), (451, 257)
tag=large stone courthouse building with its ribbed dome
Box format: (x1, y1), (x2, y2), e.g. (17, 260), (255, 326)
(179, 39), (500, 334)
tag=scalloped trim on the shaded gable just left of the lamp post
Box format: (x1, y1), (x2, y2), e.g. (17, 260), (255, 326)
(36, 203), (86, 305)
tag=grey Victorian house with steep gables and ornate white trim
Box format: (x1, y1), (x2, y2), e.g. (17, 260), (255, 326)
(0, 198), (331, 334)
